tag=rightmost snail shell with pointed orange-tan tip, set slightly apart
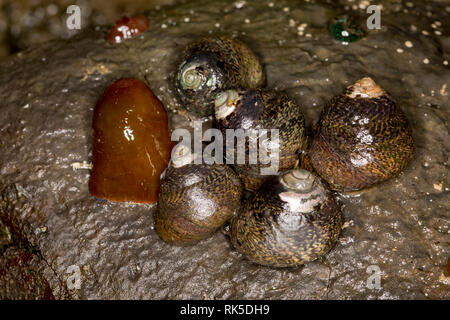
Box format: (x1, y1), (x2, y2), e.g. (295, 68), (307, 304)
(309, 77), (414, 191)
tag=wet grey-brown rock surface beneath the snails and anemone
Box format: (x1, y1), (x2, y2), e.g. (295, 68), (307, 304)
(0, 0), (450, 299)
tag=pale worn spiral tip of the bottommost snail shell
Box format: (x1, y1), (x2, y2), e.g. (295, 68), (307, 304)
(279, 169), (326, 213)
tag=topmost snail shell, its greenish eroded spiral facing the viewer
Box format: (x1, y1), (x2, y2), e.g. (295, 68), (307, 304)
(176, 37), (265, 116)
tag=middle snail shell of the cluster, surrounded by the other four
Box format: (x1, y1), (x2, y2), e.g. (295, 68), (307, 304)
(214, 89), (307, 191)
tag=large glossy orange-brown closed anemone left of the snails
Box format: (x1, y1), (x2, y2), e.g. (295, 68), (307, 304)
(89, 78), (173, 203)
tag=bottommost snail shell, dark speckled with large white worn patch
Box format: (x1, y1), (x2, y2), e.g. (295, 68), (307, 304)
(230, 169), (342, 267)
